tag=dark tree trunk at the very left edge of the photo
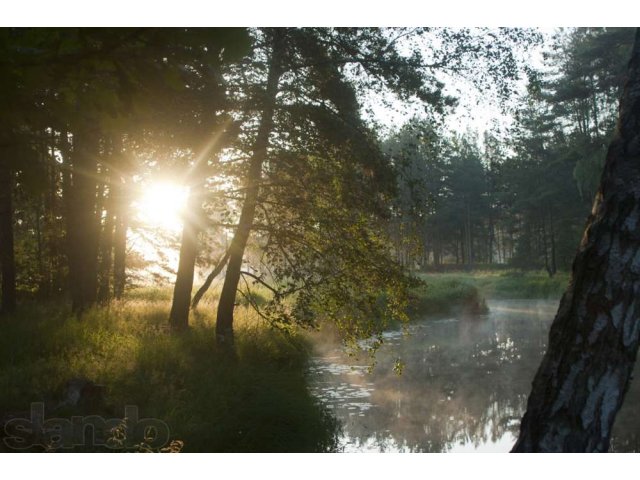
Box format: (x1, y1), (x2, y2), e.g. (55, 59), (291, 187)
(0, 161), (16, 313)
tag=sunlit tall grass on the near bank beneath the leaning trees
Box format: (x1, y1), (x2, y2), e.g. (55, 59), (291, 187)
(0, 290), (339, 452)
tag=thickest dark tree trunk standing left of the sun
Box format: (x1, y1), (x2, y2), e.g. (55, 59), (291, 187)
(67, 129), (99, 313)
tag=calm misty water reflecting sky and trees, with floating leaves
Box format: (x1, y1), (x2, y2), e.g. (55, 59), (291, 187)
(310, 300), (640, 452)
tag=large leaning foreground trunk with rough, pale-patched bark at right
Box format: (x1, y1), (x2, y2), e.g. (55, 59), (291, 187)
(513, 30), (640, 452)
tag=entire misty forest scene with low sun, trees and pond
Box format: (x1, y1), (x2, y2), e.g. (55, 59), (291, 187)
(0, 27), (640, 453)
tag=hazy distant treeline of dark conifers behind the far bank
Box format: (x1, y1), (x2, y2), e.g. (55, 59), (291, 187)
(385, 28), (634, 276)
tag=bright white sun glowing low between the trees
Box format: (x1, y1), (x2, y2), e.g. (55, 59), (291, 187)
(135, 182), (189, 233)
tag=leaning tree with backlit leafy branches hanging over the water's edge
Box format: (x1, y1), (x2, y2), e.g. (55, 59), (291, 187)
(209, 28), (526, 343)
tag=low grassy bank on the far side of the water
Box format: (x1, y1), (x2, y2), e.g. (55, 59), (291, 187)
(411, 271), (569, 315)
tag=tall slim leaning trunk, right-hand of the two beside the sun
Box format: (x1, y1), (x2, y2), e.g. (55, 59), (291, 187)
(216, 29), (284, 345)
